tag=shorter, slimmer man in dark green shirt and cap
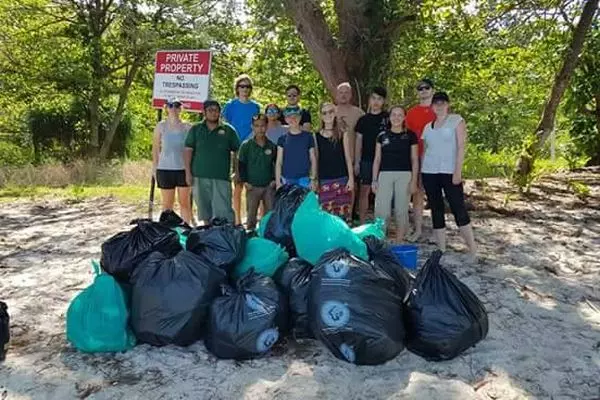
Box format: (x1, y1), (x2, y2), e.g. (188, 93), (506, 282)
(238, 114), (277, 230)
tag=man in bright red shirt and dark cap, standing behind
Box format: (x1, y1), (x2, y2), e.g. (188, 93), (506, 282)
(405, 78), (436, 241)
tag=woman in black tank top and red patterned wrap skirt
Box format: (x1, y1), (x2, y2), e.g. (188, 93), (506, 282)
(315, 103), (354, 221)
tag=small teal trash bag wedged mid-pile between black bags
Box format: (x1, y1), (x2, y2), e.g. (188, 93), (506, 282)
(233, 238), (290, 279)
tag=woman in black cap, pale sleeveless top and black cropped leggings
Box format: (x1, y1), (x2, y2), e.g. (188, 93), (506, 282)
(421, 92), (476, 257)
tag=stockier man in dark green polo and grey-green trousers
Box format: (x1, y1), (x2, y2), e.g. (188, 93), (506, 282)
(184, 100), (240, 223)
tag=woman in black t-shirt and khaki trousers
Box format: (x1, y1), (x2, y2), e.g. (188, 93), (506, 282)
(371, 106), (419, 243)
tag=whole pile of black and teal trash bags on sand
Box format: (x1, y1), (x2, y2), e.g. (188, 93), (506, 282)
(64, 186), (488, 365)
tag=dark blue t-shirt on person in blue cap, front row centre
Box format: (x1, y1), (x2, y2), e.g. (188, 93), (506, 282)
(277, 131), (315, 179)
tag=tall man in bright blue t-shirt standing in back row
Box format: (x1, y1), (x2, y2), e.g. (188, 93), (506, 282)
(223, 74), (261, 224)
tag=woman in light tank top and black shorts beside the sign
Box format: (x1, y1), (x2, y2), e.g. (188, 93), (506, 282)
(152, 99), (192, 224)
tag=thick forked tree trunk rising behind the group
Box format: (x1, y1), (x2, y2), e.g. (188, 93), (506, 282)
(284, 0), (419, 101)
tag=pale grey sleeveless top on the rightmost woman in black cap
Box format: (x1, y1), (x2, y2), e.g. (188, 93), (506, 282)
(421, 114), (463, 174)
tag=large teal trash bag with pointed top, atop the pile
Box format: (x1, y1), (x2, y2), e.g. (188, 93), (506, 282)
(292, 192), (369, 265)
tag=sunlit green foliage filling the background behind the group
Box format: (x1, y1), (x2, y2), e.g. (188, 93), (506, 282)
(0, 0), (600, 183)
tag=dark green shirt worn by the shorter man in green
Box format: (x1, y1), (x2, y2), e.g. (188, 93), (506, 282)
(239, 138), (277, 187)
